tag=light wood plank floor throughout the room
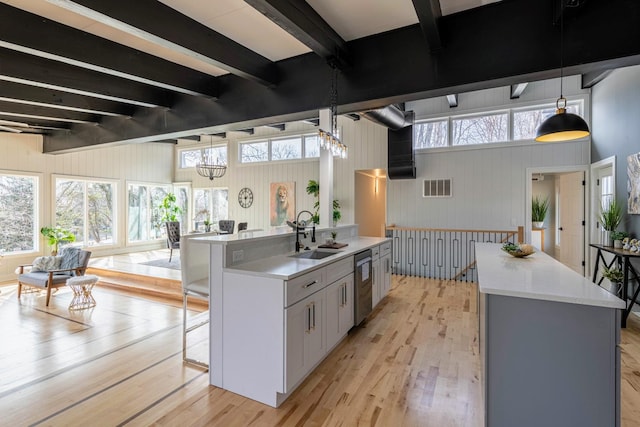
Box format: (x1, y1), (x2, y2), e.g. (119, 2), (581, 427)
(0, 276), (640, 427)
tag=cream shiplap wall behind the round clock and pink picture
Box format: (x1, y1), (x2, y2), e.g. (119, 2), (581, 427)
(175, 116), (387, 229)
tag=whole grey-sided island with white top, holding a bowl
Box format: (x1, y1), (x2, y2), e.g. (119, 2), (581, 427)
(475, 243), (625, 427)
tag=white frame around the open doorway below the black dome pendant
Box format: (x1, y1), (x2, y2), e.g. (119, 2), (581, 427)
(524, 165), (591, 277)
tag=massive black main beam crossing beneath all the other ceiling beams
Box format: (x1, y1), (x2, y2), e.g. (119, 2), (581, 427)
(44, 0), (640, 152)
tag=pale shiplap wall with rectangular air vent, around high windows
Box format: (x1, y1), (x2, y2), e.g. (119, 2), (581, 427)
(387, 77), (590, 230)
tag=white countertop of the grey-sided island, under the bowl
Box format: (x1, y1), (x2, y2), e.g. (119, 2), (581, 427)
(475, 243), (625, 308)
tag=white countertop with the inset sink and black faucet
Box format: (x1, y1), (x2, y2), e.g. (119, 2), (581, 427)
(224, 237), (391, 280)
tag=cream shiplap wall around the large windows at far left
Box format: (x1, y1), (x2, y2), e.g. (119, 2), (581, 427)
(0, 133), (174, 280)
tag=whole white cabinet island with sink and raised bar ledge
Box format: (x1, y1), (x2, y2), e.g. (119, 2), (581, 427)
(190, 226), (390, 407)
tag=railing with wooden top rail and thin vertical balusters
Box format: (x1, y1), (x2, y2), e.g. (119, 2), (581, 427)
(386, 226), (524, 282)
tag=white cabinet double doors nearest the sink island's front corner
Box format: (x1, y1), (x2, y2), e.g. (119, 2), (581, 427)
(285, 290), (327, 392)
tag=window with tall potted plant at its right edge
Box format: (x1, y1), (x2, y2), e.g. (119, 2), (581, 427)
(127, 184), (169, 242)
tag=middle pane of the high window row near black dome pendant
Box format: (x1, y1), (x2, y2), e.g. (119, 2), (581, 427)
(451, 113), (509, 145)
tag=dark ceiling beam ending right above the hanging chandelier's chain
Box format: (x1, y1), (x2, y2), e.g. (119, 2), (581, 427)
(245, 0), (351, 70)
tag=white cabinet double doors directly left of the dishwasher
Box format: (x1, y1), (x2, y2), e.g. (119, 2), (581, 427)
(326, 273), (354, 350)
